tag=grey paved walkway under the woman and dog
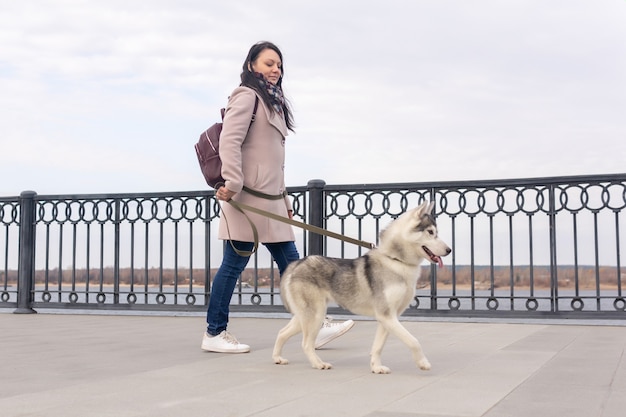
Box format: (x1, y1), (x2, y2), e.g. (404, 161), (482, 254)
(0, 313), (626, 417)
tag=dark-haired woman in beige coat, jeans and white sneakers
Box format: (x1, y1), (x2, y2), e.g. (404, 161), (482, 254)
(202, 42), (354, 353)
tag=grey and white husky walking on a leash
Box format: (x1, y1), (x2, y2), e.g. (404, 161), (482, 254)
(272, 203), (452, 374)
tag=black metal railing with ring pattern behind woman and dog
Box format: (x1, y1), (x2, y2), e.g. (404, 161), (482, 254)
(0, 174), (626, 319)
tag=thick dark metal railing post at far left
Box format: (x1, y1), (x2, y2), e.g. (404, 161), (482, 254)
(14, 191), (37, 314)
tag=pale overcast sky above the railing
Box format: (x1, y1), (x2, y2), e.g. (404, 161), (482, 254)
(0, 0), (626, 196)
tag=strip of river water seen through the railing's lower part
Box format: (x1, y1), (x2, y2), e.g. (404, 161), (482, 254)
(0, 284), (626, 312)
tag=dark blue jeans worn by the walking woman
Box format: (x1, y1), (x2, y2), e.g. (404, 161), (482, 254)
(206, 240), (300, 336)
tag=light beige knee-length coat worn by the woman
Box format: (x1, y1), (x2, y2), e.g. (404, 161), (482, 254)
(218, 87), (295, 243)
